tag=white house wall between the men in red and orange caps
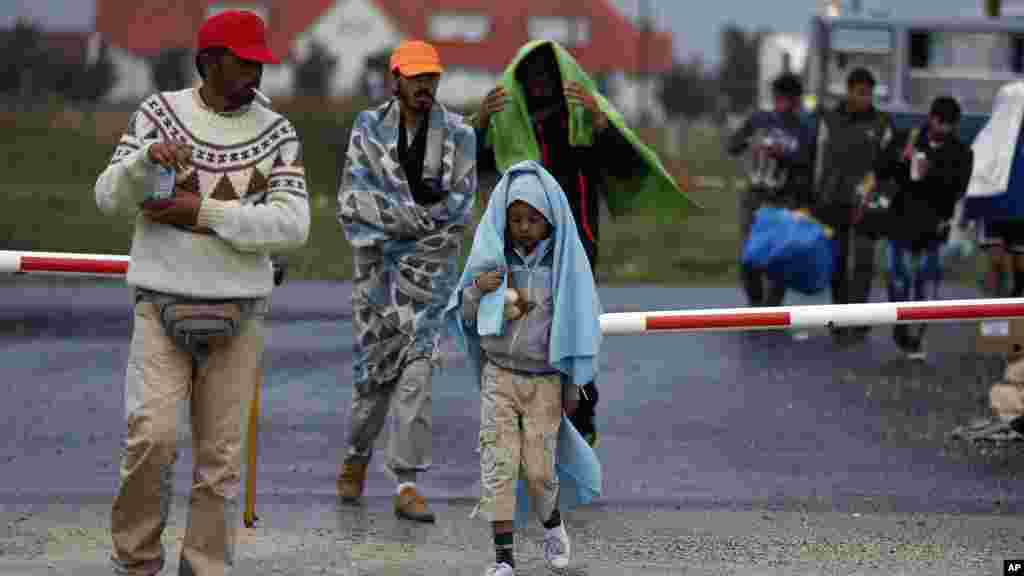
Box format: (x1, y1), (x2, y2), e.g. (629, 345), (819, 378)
(292, 0), (401, 96)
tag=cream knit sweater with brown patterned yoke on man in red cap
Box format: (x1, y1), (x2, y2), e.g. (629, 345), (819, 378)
(95, 89), (309, 298)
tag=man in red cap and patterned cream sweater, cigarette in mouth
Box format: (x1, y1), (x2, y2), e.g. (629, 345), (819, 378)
(95, 11), (309, 576)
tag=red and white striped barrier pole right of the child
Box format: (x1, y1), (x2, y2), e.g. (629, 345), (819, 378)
(601, 298), (1024, 335)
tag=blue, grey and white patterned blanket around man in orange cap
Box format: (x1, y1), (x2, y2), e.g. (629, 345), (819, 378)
(338, 100), (476, 386)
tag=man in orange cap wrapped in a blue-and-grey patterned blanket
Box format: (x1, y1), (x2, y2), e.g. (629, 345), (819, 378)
(338, 41), (476, 522)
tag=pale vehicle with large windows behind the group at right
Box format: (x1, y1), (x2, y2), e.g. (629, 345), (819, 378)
(805, 16), (1024, 141)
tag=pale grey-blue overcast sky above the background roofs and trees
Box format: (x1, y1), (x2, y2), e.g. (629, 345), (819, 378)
(0, 0), (991, 63)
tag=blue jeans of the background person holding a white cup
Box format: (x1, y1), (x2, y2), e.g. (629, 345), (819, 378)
(887, 241), (942, 349)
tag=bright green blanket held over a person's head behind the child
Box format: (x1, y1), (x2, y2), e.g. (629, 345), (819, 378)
(486, 40), (700, 221)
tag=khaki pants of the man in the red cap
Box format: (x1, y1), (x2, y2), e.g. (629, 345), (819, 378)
(111, 301), (265, 576)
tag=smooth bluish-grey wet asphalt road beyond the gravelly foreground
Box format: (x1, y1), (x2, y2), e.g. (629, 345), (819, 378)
(0, 282), (1024, 574)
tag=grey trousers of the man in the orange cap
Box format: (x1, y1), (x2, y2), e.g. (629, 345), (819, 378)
(345, 358), (433, 475)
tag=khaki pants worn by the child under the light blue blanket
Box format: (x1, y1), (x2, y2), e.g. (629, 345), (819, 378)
(473, 362), (562, 522)
